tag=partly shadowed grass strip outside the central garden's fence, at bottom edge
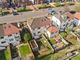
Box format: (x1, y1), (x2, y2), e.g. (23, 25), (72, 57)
(36, 48), (67, 60)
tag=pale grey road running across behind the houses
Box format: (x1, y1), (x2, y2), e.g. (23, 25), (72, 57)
(0, 6), (74, 24)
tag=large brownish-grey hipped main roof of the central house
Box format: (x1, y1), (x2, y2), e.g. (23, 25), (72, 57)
(31, 17), (51, 29)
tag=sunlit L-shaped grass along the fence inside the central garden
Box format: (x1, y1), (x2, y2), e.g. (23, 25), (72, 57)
(38, 35), (53, 57)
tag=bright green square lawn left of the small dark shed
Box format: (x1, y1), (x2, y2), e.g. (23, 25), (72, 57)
(19, 43), (31, 57)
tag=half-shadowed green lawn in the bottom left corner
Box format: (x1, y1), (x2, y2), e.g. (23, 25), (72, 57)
(0, 49), (11, 60)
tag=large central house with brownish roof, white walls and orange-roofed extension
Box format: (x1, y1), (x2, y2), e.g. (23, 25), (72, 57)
(28, 17), (57, 39)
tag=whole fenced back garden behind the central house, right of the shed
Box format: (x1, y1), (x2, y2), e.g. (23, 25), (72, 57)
(37, 36), (54, 57)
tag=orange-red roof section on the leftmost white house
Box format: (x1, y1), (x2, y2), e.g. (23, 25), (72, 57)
(3, 24), (19, 35)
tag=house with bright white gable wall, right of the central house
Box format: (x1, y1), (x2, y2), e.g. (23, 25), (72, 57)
(51, 13), (68, 31)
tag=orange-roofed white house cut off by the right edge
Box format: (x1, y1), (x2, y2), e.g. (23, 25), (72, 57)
(67, 12), (80, 26)
